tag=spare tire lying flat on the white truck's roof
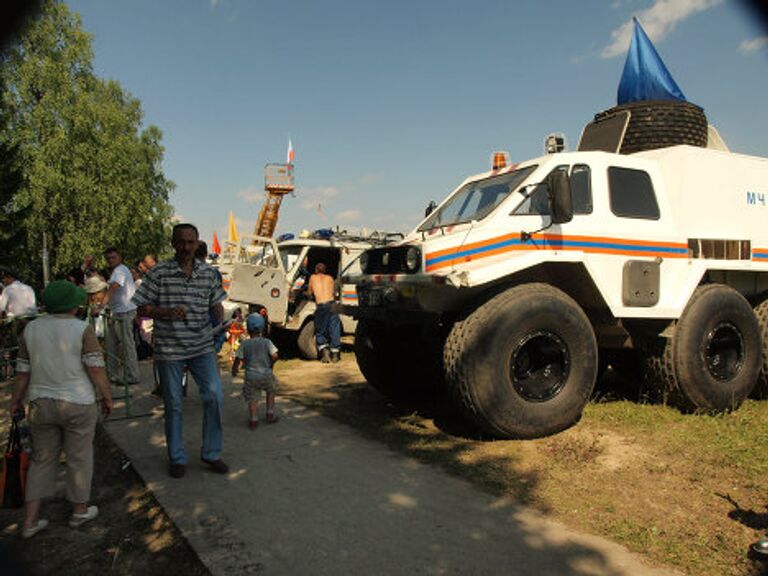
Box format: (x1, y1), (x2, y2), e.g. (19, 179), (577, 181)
(595, 100), (708, 154)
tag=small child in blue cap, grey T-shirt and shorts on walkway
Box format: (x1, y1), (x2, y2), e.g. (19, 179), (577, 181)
(232, 314), (278, 430)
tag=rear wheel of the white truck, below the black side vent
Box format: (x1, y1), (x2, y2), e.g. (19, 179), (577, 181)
(649, 284), (763, 412)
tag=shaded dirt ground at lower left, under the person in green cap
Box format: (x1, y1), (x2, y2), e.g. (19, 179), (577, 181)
(0, 365), (209, 576)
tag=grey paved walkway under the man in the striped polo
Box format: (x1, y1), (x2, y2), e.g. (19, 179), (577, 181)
(106, 364), (676, 576)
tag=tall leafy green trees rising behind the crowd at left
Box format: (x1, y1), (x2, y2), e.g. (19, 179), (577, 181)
(0, 0), (174, 286)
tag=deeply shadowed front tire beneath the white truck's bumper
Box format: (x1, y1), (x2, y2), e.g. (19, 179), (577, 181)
(354, 319), (442, 402)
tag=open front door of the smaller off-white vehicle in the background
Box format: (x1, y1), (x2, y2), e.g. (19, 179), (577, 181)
(229, 238), (290, 324)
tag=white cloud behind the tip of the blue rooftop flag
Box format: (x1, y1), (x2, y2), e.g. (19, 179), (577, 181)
(601, 0), (723, 58)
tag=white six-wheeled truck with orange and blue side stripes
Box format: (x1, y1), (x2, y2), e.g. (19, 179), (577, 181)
(347, 143), (768, 438)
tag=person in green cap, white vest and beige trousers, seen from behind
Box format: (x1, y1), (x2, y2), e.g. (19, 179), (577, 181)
(10, 280), (112, 538)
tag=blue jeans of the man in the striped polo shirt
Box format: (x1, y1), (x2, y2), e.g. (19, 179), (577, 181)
(157, 352), (223, 464)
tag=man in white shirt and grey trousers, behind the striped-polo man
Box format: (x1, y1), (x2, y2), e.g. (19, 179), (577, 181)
(104, 247), (141, 384)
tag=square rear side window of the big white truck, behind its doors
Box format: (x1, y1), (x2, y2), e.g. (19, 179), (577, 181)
(608, 166), (660, 220)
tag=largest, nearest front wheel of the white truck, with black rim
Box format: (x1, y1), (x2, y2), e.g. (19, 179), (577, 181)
(444, 284), (597, 438)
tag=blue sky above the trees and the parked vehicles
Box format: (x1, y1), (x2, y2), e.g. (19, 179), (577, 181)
(67, 0), (768, 241)
